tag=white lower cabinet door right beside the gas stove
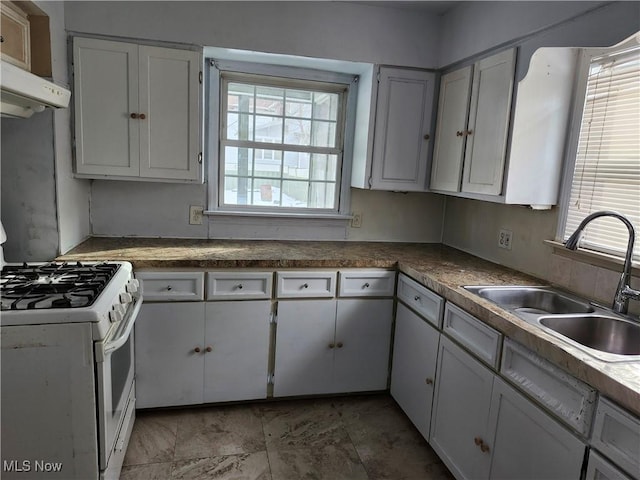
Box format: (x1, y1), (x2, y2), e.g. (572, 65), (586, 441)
(135, 302), (205, 408)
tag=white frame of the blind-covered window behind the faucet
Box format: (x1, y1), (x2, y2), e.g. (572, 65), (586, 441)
(555, 34), (640, 268)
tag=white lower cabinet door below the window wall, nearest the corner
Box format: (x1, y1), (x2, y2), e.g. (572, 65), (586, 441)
(332, 298), (393, 393)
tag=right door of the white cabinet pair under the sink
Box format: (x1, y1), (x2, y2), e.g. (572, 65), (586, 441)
(489, 378), (586, 480)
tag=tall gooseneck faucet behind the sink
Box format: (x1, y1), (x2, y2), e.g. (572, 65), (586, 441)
(565, 210), (640, 314)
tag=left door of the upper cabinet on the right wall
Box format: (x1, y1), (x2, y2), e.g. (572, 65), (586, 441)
(431, 65), (472, 192)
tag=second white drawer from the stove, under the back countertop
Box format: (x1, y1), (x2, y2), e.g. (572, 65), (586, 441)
(207, 272), (273, 300)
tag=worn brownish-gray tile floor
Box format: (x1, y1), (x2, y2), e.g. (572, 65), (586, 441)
(120, 394), (453, 480)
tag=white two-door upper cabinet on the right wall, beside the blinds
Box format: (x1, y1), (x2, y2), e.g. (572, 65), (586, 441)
(430, 48), (576, 209)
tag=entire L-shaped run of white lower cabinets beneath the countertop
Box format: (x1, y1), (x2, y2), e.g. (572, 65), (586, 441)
(135, 269), (640, 480)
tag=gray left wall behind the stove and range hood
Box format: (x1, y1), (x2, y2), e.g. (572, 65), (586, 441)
(1, 2), (90, 261)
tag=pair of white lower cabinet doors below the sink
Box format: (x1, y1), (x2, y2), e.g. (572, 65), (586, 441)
(431, 336), (586, 480)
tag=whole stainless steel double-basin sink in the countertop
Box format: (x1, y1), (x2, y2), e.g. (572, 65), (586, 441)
(464, 286), (640, 362)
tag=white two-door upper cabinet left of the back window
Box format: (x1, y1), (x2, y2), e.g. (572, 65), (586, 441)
(73, 37), (202, 182)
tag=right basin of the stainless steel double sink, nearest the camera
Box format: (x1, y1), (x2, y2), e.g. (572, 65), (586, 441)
(539, 315), (640, 355)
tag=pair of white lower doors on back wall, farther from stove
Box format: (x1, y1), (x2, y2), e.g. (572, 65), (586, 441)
(273, 299), (393, 397)
